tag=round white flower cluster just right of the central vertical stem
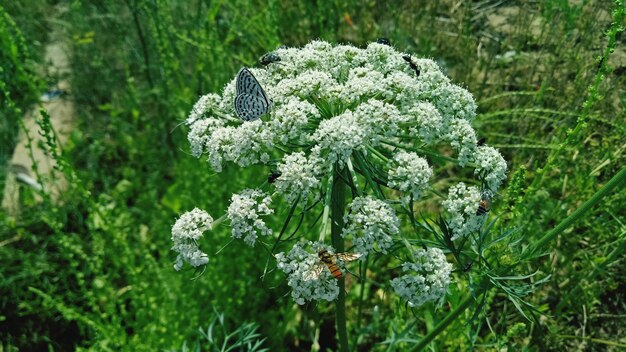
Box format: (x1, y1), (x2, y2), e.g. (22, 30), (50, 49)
(341, 197), (400, 254)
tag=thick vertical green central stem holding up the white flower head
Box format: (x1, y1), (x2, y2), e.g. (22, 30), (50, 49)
(330, 167), (350, 352)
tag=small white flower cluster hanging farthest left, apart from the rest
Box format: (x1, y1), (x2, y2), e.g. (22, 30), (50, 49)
(172, 208), (213, 271)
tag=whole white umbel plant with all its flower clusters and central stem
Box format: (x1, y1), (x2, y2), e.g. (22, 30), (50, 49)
(172, 41), (507, 349)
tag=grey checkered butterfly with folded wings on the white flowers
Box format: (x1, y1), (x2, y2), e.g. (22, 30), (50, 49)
(235, 67), (272, 121)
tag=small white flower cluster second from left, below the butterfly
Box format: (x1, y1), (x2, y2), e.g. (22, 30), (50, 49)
(227, 189), (274, 246)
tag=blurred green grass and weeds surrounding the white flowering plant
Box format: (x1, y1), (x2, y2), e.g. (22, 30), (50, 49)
(0, 0), (626, 351)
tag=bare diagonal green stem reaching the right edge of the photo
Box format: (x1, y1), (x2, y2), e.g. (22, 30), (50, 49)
(526, 167), (626, 258)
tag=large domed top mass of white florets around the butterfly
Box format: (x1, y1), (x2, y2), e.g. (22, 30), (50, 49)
(187, 41), (492, 177)
